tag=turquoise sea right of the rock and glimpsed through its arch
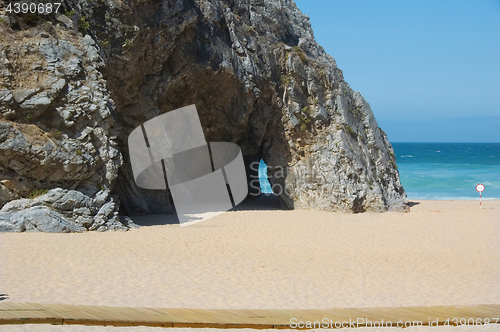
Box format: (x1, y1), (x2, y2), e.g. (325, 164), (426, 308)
(259, 143), (500, 200)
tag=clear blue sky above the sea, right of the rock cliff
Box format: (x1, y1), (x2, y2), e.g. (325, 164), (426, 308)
(295, 0), (500, 142)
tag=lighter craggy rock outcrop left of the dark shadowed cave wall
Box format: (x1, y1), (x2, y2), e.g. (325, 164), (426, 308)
(0, 6), (127, 232)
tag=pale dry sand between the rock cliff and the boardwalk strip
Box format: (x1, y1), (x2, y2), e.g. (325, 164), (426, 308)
(0, 197), (500, 312)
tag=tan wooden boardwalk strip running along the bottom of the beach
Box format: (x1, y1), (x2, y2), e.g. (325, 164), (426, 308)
(0, 302), (500, 329)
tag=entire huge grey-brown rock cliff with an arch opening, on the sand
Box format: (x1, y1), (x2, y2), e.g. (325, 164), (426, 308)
(0, 0), (406, 232)
